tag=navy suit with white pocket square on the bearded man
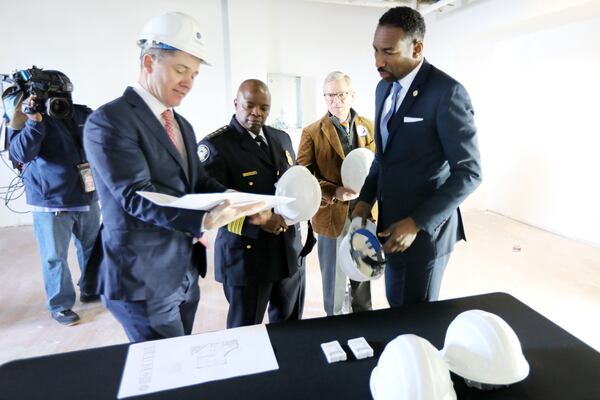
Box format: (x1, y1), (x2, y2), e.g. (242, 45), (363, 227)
(359, 60), (481, 306)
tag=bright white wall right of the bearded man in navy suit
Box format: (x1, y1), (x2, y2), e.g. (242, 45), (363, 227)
(426, 0), (600, 245)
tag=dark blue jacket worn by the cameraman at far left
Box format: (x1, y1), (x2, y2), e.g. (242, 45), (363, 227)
(8, 105), (96, 208)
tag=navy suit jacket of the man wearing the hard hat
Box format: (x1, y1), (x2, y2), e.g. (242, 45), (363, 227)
(84, 88), (226, 339)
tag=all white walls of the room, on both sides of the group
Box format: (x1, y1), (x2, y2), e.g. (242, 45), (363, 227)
(0, 0), (600, 244)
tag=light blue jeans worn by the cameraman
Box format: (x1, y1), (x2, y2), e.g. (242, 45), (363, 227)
(32, 202), (100, 312)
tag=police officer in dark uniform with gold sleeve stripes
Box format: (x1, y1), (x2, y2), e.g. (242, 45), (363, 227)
(198, 79), (305, 328)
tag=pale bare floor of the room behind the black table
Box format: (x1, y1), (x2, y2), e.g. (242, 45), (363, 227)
(0, 210), (600, 364)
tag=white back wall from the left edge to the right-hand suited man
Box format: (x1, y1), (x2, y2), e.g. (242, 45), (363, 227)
(0, 0), (381, 226)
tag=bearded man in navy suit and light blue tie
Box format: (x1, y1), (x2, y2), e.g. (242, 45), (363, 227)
(353, 7), (481, 307)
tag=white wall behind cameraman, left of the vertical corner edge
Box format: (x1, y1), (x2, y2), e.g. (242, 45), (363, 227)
(0, 0), (227, 226)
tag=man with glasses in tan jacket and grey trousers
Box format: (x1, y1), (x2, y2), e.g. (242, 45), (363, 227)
(297, 71), (375, 315)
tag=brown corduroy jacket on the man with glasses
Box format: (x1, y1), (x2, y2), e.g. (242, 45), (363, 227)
(297, 113), (375, 238)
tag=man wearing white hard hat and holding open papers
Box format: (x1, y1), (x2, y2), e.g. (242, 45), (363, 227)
(84, 13), (261, 341)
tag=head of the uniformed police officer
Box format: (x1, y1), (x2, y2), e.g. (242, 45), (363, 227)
(233, 79), (271, 134)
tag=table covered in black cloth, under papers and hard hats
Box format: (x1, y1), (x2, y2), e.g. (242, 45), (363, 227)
(0, 293), (600, 400)
